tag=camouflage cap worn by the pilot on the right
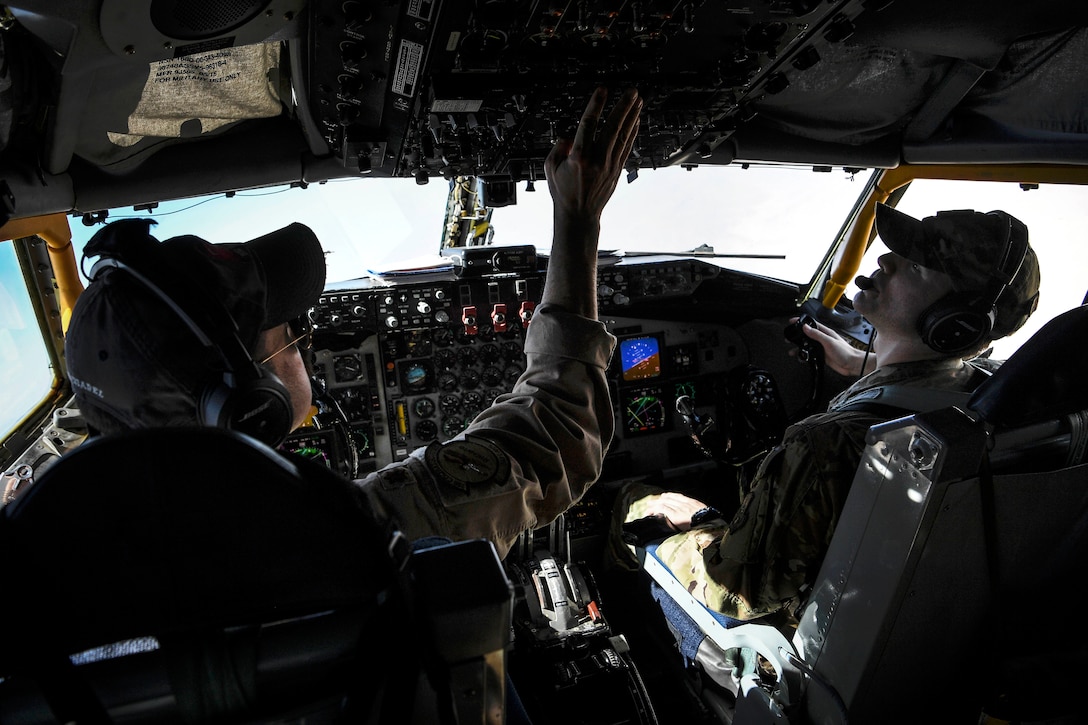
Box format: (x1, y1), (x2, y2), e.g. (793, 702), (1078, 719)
(877, 204), (1040, 340)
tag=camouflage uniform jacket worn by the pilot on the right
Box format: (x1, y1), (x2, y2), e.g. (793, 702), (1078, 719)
(644, 359), (987, 624)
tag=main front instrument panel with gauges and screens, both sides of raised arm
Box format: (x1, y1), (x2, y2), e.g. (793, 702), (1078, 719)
(288, 253), (800, 477)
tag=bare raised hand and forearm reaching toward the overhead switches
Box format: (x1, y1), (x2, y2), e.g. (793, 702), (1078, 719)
(541, 88), (642, 319)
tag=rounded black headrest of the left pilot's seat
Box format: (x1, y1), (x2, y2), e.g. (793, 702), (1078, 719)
(0, 428), (395, 663)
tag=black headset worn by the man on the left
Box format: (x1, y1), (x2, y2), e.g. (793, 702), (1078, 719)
(85, 219), (294, 447)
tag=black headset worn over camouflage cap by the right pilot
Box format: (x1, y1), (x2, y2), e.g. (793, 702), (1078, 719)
(918, 212), (1027, 355)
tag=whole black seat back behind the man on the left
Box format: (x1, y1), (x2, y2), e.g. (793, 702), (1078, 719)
(0, 428), (512, 723)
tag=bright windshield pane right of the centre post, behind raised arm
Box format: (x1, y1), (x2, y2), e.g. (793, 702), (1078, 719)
(492, 165), (868, 282)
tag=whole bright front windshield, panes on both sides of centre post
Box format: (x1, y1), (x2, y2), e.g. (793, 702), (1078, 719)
(65, 167), (868, 284)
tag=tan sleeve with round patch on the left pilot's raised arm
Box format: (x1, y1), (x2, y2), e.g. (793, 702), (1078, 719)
(357, 305), (616, 556)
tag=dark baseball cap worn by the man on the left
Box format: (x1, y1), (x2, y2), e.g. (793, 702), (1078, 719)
(64, 219), (325, 432)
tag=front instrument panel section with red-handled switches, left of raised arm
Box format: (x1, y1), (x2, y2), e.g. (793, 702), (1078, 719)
(311, 269), (544, 465)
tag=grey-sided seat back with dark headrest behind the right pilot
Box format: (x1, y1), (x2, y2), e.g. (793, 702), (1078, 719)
(791, 308), (1088, 723)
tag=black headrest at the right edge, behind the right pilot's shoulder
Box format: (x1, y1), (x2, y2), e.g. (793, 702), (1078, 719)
(967, 306), (1088, 428)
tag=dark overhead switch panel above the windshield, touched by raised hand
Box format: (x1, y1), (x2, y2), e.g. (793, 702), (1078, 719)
(301, 0), (866, 177)
